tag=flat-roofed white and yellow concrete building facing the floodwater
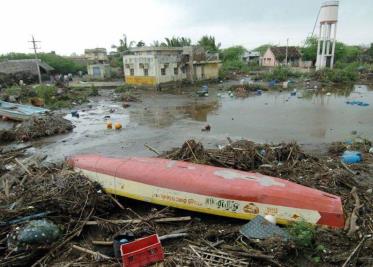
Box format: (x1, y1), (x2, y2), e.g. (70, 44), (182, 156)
(123, 46), (220, 86)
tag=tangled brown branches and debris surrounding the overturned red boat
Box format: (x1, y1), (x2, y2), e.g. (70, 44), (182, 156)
(0, 139), (373, 266)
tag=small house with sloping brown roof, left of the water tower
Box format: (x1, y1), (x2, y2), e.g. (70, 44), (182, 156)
(261, 46), (302, 67)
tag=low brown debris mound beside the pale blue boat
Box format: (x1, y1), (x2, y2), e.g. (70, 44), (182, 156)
(0, 114), (73, 143)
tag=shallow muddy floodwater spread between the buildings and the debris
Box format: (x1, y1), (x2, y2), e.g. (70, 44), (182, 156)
(1, 85), (373, 160)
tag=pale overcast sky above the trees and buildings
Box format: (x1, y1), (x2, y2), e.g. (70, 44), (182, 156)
(0, 0), (373, 55)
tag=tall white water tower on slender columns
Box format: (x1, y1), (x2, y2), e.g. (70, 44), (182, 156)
(316, 1), (339, 70)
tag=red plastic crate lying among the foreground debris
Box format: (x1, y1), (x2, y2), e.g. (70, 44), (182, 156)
(120, 234), (164, 267)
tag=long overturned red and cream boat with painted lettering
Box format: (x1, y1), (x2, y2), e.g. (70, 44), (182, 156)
(68, 155), (344, 228)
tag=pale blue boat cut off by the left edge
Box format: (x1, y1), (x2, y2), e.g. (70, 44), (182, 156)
(0, 100), (49, 121)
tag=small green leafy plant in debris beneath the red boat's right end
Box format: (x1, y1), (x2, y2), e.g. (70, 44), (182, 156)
(288, 221), (315, 248)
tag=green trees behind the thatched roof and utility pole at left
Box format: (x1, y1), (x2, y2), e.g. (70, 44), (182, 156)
(0, 53), (86, 74)
